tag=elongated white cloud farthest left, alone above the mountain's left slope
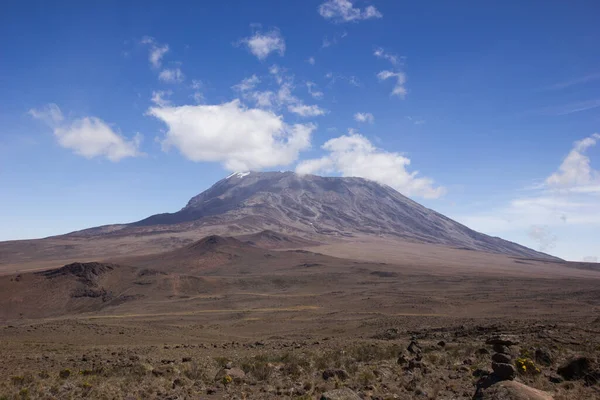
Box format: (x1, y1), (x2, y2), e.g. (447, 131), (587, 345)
(29, 104), (142, 162)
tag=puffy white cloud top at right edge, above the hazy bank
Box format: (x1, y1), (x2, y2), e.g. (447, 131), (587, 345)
(546, 133), (600, 188)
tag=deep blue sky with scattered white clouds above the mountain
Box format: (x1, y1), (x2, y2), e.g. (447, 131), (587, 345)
(0, 0), (600, 260)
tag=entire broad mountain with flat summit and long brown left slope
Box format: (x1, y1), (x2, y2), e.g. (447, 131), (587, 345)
(0, 172), (558, 272)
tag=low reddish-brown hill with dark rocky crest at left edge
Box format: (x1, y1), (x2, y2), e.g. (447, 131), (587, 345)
(0, 262), (208, 320)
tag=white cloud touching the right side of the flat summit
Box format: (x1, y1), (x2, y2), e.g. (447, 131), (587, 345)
(296, 131), (445, 198)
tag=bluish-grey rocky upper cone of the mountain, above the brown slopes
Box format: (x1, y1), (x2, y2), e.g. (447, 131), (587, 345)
(121, 172), (551, 258)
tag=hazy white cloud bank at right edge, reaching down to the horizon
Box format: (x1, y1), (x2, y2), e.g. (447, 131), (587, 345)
(456, 134), (600, 260)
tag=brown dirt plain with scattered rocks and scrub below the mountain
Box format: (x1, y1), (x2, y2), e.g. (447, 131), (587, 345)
(0, 239), (600, 400)
